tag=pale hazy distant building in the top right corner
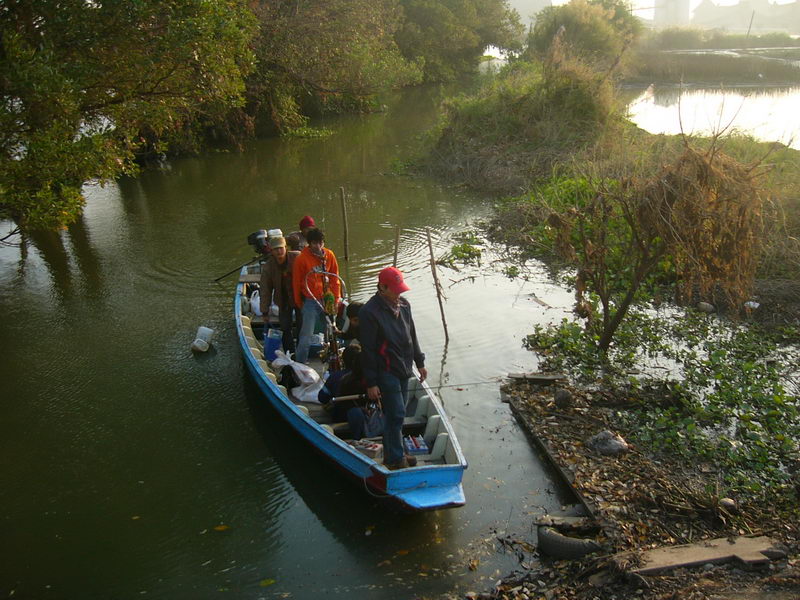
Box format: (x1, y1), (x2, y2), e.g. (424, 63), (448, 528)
(692, 0), (800, 33)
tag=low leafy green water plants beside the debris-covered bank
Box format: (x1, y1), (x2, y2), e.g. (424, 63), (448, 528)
(527, 311), (800, 496)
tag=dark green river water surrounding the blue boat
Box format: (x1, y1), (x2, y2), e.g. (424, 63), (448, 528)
(0, 88), (570, 599)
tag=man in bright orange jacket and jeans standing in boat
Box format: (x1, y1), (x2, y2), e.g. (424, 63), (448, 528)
(292, 228), (342, 363)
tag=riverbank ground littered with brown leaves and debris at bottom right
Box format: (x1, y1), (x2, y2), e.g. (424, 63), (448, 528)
(460, 381), (800, 600)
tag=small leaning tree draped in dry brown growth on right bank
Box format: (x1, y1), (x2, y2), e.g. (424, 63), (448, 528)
(548, 140), (763, 352)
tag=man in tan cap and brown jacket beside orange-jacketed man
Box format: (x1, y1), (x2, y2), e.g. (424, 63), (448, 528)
(260, 237), (301, 353)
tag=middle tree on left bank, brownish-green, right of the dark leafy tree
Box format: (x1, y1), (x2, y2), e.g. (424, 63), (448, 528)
(247, 0), (420, 131)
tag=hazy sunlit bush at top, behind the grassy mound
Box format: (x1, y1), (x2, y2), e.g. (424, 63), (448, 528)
(525, 0), (642, 71)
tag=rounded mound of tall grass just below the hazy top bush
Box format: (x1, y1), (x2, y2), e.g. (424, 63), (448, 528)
(428, 58), (619, 194)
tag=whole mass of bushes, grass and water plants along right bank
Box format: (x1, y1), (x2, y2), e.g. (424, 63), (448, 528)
(425, 0), (800, 506)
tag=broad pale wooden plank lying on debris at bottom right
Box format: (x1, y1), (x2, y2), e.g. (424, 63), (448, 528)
(633, 535), (782, 575)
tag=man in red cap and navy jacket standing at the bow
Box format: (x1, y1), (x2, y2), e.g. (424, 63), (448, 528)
(358, 267), (428, 470)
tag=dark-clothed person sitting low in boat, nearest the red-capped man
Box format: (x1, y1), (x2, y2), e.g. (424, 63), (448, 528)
(317, 344), (376, 440)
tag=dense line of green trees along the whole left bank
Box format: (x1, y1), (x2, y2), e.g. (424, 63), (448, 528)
(0, 0), (521, 234)
